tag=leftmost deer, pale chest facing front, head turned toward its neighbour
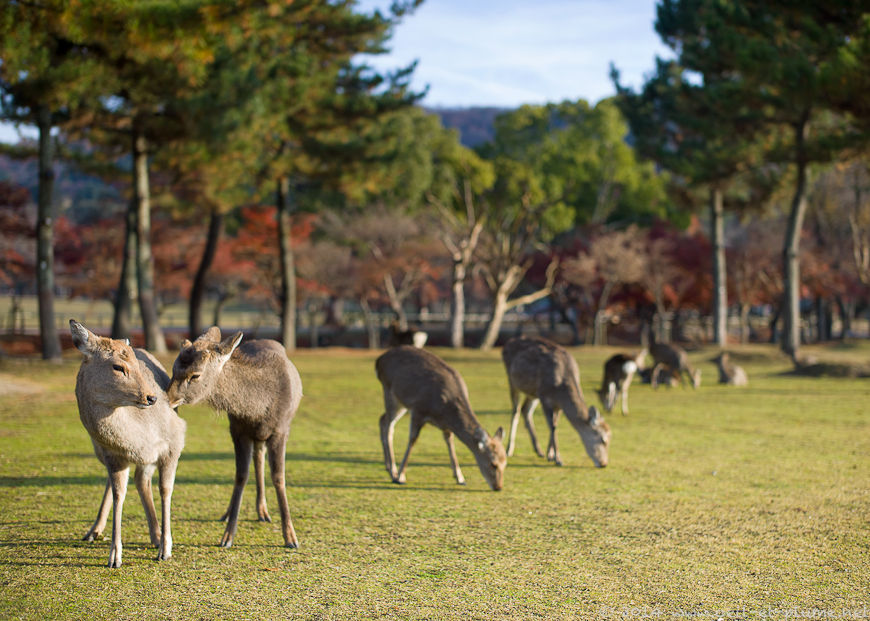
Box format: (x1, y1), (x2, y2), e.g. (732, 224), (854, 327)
(69, 319), (187, 569)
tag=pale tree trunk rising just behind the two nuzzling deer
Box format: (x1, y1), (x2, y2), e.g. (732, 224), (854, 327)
(133, 123), (167, 354)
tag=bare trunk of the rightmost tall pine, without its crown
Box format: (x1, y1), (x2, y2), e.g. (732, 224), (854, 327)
(782, 121), (808, 361)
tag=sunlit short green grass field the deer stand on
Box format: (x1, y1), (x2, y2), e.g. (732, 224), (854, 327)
(0, 344), (870, 620)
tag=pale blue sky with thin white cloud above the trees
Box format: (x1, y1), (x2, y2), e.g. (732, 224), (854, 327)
(0, 0), (673, 142)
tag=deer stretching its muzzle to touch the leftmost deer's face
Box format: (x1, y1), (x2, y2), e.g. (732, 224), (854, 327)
(167, 326), (302, 548)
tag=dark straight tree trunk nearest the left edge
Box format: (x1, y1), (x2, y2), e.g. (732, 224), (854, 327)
(36, 105), (61, 360)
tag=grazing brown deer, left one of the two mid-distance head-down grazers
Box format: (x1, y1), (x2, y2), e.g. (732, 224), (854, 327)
(375, 345), (507, 491)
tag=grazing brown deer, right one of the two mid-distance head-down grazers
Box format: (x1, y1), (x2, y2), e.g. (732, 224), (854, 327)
(502, 336), (610, 468)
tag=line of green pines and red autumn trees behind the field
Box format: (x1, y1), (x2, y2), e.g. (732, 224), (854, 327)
(0, 0), (870, 358)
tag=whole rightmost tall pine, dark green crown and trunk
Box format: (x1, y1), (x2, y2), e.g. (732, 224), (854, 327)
(656, 0), (865, 360)
